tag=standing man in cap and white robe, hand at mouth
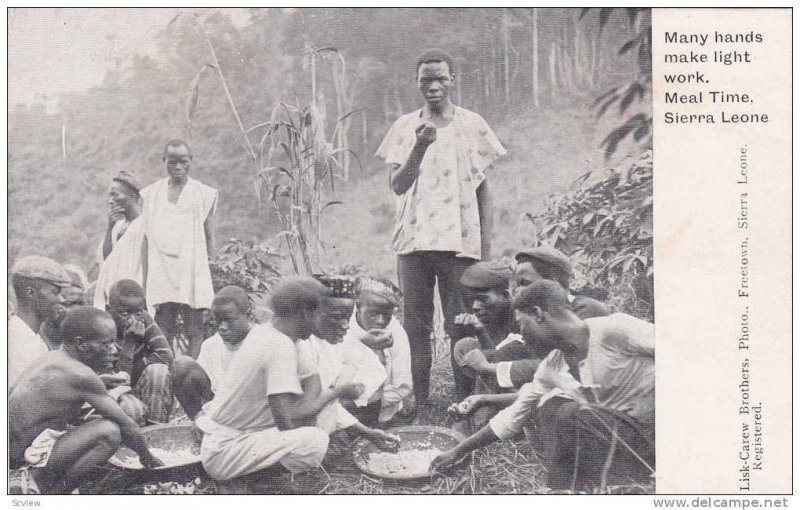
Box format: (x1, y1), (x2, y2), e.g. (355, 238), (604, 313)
(92, 171), (147, 310)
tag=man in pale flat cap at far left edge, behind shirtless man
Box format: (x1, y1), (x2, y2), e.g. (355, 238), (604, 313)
(8, 255), (72, 391)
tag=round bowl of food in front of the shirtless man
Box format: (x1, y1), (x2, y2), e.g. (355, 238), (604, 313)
(108, 423), (200, 471)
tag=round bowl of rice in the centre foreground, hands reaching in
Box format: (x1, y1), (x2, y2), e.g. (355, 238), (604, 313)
(353, 425), (466, 480)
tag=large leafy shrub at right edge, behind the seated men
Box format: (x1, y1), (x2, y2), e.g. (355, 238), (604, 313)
(528, 150), (653, 319)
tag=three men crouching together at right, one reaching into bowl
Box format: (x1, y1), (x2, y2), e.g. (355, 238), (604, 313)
(433, 246), (655, 492)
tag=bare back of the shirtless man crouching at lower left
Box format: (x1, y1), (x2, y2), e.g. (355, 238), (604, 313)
(8, 350), (103, 460)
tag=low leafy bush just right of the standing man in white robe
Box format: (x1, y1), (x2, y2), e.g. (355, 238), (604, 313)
(211, 239), (281, 297)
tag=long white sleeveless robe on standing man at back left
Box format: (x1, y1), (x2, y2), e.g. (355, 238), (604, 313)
(141, 178), (218, 308)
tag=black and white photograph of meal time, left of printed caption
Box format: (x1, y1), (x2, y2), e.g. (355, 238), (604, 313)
(7, 7), (658, 496)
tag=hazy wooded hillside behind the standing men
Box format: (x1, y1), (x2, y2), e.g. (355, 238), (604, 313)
(8, 9), (647, 282)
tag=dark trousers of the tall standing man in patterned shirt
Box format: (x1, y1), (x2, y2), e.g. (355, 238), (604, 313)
(397, 251), (478, 403)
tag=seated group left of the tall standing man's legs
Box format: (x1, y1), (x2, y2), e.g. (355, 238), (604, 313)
(9, 256), (412, 493)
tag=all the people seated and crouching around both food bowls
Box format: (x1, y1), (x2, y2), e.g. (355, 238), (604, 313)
(8, 243), (655, 493)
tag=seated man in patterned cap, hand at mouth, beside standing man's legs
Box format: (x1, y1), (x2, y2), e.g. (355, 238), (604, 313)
(344, 277), (414, 426)
